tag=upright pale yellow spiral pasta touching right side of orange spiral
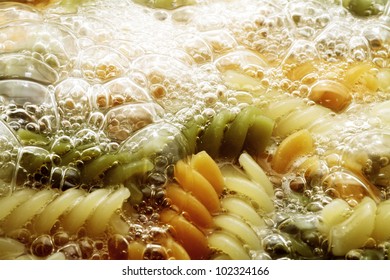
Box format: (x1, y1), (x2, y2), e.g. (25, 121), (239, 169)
(208, 153), (274, 259)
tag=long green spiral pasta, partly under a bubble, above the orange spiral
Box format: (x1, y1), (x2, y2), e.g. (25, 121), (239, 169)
(81, 106), (274, 198)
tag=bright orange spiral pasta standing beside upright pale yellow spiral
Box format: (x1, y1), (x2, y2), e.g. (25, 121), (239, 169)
(157, 152), (223, 259)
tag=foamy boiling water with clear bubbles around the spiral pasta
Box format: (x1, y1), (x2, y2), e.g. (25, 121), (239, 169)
(0, 0), (390, 259)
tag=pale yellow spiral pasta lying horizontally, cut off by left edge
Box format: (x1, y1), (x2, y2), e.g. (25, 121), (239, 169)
(0, 187), (130, 236)
